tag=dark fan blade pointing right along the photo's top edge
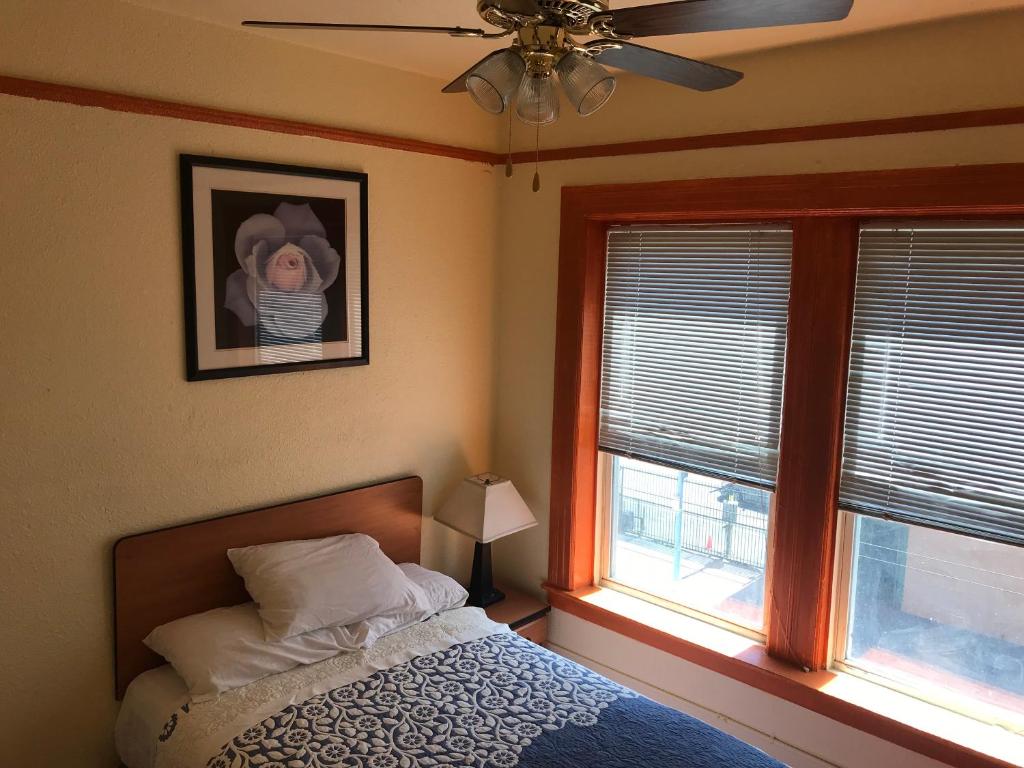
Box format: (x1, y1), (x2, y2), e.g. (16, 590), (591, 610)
(591, 0), (853, 37)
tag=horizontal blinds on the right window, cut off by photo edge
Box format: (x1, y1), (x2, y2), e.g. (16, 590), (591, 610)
(841, 221), (1024, 545)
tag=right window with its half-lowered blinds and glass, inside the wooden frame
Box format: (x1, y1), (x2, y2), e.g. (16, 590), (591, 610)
(837, 222), (1024, 727)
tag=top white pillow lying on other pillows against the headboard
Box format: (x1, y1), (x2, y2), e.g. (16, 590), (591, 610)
(227, 534), (428, 640)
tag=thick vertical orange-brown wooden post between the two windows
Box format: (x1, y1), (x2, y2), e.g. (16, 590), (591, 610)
(766, 218), (858, 670)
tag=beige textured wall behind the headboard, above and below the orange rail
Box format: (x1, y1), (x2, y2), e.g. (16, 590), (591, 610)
(0, 0), (497, 768)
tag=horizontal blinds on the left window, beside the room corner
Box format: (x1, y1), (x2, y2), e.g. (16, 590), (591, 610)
(599, 224), (793, 488)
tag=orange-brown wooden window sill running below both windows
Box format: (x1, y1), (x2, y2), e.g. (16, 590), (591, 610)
(547, 586), (1019, 768)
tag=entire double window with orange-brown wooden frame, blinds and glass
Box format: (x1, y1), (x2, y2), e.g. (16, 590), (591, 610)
(547, 165), (1024, 765)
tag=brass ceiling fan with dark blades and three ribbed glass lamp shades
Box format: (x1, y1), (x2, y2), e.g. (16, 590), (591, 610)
(242, 0), (853, 186)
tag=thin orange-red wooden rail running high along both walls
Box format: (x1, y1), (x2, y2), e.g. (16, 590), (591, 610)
(0, 75), (1024, 166)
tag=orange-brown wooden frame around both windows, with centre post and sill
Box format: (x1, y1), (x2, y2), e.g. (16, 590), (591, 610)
(546, 164), (1024, 768)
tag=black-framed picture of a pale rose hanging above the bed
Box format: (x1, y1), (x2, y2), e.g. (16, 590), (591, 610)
(181, 155), (370, 381)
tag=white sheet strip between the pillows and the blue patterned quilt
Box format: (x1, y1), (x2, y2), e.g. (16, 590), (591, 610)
(115, 608), (510, 768)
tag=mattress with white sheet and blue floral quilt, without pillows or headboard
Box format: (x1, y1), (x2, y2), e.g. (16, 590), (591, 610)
(117, 608), (782, 768)
